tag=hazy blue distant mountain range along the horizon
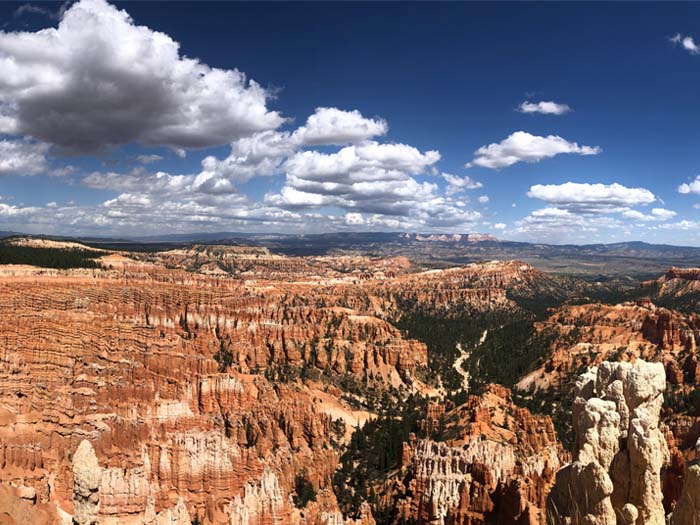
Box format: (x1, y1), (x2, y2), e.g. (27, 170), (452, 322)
(0, 232), (700, 278)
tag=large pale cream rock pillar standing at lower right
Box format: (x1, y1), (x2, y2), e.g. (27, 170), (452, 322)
(548, 360), (670, 525)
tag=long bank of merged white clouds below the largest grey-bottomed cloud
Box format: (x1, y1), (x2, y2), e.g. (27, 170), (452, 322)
(68, 103), (481, 230)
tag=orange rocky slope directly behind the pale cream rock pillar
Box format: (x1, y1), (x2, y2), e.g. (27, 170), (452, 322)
(517, 292), (700, 514)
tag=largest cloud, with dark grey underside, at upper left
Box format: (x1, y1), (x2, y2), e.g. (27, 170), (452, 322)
(0, 0), (284, 152)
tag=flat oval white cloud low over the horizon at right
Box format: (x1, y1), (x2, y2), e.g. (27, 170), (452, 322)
(527, 182), (656, 213)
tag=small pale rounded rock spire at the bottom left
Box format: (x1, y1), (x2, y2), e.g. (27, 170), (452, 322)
(73, 440), (102, 525)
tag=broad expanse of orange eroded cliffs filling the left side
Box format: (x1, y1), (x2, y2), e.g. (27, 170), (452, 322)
(0, 251), (539, 525)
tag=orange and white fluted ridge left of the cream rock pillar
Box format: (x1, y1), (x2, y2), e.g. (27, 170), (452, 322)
(385, 385), (568, 525)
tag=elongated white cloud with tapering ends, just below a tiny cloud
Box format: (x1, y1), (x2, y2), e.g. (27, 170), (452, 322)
(466, 131), (602, 169)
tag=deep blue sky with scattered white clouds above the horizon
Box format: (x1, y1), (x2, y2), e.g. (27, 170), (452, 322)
(0, 0), (700, 246)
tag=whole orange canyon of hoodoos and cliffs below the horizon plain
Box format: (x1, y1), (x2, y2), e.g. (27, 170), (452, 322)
(0, 240), (700, 525)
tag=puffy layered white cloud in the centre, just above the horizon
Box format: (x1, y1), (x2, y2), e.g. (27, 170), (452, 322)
(265, 140), (481, 229)
